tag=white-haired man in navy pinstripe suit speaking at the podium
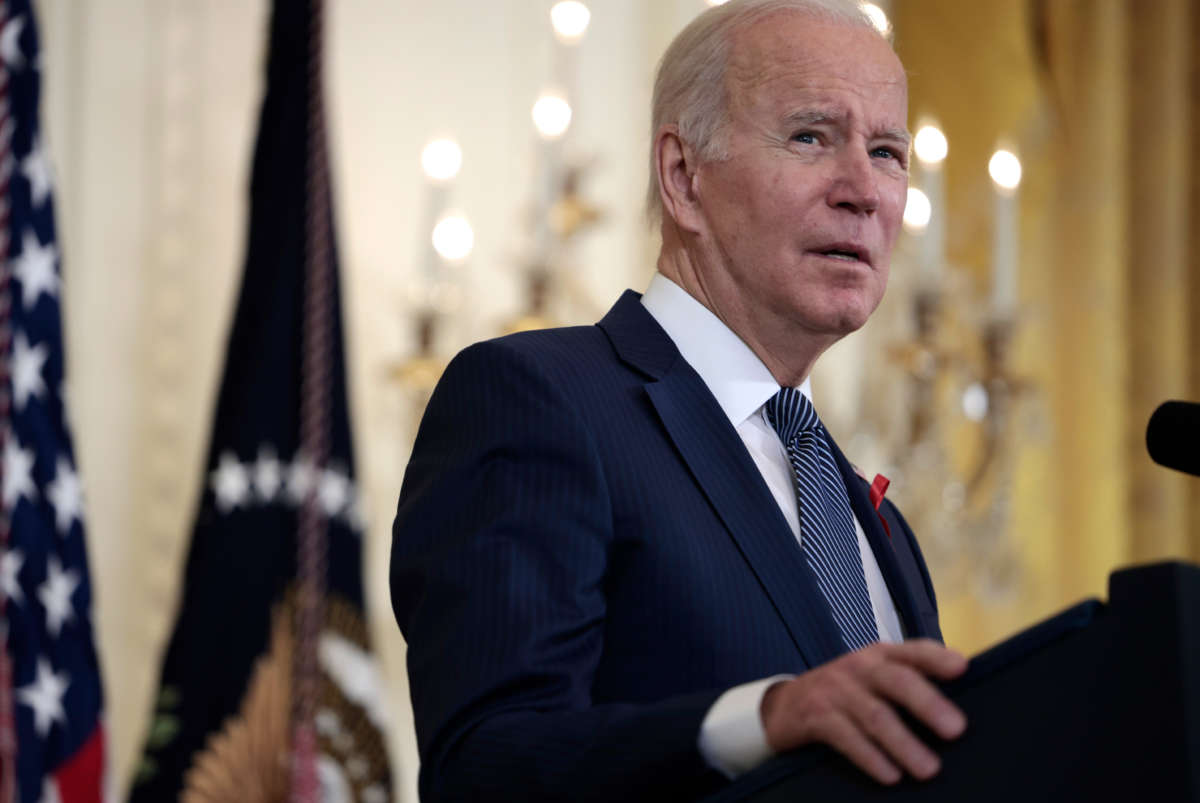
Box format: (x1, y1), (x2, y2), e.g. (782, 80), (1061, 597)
(391, 0), (966, 799)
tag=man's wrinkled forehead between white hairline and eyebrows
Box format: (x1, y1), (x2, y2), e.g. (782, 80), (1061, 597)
(725, 11), (907, 103)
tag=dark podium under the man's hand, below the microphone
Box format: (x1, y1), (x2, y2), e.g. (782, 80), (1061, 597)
(706, 563), (1200, 803)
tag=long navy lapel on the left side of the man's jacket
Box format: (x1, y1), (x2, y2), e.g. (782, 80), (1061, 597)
(600, 292), (846, 666)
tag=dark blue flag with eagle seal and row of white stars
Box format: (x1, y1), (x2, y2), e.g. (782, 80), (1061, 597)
(131, 0), (391, 803)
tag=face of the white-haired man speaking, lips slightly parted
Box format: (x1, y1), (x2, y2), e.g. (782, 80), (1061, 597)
(695, 13), (908, 348)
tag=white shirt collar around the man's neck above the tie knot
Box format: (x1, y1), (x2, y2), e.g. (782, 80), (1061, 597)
(642, 272), (812, 426)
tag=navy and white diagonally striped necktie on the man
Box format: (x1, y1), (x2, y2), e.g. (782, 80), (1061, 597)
(767, 388), (880, 649)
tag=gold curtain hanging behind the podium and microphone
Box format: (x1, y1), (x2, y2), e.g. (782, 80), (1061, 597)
(893, 0), (1200, 651)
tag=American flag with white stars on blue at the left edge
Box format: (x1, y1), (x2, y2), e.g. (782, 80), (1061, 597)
(0, 0), (104, 803)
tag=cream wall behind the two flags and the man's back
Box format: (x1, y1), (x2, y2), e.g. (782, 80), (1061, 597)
(37, 0), (720, 799)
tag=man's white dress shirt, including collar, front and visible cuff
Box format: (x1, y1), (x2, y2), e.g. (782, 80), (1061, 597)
(642, 272), (904, 778)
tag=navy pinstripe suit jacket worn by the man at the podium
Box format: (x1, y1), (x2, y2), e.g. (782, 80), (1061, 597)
(391, 292), (941, 801)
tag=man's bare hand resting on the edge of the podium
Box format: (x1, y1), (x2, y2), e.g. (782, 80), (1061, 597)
(761, 639), (967, 784)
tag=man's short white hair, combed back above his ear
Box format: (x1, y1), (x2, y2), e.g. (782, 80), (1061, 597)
(646, 0), (886, 222)
